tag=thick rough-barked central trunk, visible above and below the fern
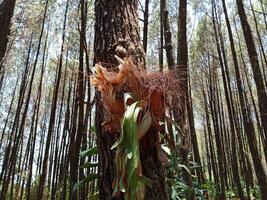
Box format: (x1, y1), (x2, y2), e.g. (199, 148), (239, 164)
(94, 0), (168, 200)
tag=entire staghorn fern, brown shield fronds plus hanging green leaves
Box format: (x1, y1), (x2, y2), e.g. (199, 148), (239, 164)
(91, 58), (182, 200)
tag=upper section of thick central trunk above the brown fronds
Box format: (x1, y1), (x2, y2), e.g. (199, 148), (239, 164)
(94, 0), (145, 70)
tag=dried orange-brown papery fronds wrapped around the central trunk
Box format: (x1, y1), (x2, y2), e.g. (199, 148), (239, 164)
(91, 58), (182, 131)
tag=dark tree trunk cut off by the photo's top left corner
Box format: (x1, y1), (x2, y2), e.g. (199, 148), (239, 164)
(0, 0), (16, 67)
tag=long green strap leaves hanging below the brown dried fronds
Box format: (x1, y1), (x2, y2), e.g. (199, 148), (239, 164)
(112, 95), (152, 200)
